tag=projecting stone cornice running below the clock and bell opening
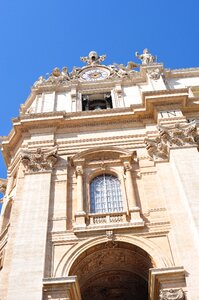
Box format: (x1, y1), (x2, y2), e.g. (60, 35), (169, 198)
(2, 88), (199, 164)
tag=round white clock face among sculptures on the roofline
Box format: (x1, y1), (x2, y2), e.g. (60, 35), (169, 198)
(80, 68), (110, 81)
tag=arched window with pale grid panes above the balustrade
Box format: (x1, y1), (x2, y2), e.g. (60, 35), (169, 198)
(90, 174), (123, 213)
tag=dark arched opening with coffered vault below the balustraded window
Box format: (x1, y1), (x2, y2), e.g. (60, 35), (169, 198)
(70, 241), (155, 300)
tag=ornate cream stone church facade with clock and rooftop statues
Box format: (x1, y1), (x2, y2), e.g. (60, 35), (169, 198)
(0, 49), (199, 300)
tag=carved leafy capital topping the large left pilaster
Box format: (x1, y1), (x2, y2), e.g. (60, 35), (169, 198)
(21, 147), (58, 172)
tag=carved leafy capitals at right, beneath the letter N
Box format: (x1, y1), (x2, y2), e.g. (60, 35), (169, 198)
(145, 122), (199, 161)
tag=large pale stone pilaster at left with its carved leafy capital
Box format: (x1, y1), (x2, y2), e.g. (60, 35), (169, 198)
(0, 150), (57, 300)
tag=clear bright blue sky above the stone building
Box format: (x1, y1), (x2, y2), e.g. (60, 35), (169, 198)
(0, 0), (199, 183)
